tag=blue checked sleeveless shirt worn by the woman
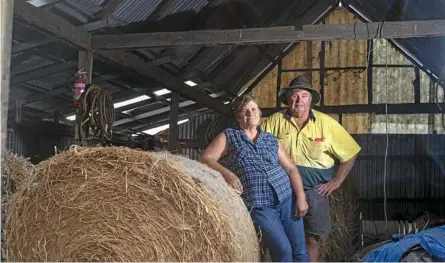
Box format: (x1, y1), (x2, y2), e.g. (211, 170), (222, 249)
(224, 128), (292, 207)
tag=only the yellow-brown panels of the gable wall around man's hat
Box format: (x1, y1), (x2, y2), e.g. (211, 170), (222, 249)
(252, 8), (371, 133)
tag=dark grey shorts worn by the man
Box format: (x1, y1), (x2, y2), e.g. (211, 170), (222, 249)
(304, 189), (332, 236)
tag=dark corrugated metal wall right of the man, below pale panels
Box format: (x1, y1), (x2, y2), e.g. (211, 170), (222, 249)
(350, 134), (445, 220)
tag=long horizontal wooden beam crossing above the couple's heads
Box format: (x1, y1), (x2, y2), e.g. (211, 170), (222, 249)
(93, 20), (445, 49)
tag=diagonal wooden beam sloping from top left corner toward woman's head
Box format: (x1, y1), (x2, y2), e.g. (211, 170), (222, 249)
(14, 1), (231, 115)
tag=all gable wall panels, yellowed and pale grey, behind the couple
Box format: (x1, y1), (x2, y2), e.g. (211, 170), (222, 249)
(252, 8), (445, 134)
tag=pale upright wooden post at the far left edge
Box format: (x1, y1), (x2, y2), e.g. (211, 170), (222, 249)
(0, 0), (14, 161)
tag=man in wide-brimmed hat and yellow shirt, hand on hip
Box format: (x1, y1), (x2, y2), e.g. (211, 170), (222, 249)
(261, 76), (361, 261)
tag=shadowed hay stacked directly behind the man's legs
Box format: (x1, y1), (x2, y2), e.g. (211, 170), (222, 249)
(320, 177), (360, 262)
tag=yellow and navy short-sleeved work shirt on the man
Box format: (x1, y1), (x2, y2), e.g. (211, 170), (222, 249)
(261, 110), (361, 190)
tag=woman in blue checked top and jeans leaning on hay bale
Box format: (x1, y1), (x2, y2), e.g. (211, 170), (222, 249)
(200, 95), (309, 262)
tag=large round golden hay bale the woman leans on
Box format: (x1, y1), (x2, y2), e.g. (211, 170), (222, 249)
(6, 147), (259, 262)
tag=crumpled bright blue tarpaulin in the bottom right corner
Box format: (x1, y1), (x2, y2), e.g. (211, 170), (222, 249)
(363, 226), (445, 262)
